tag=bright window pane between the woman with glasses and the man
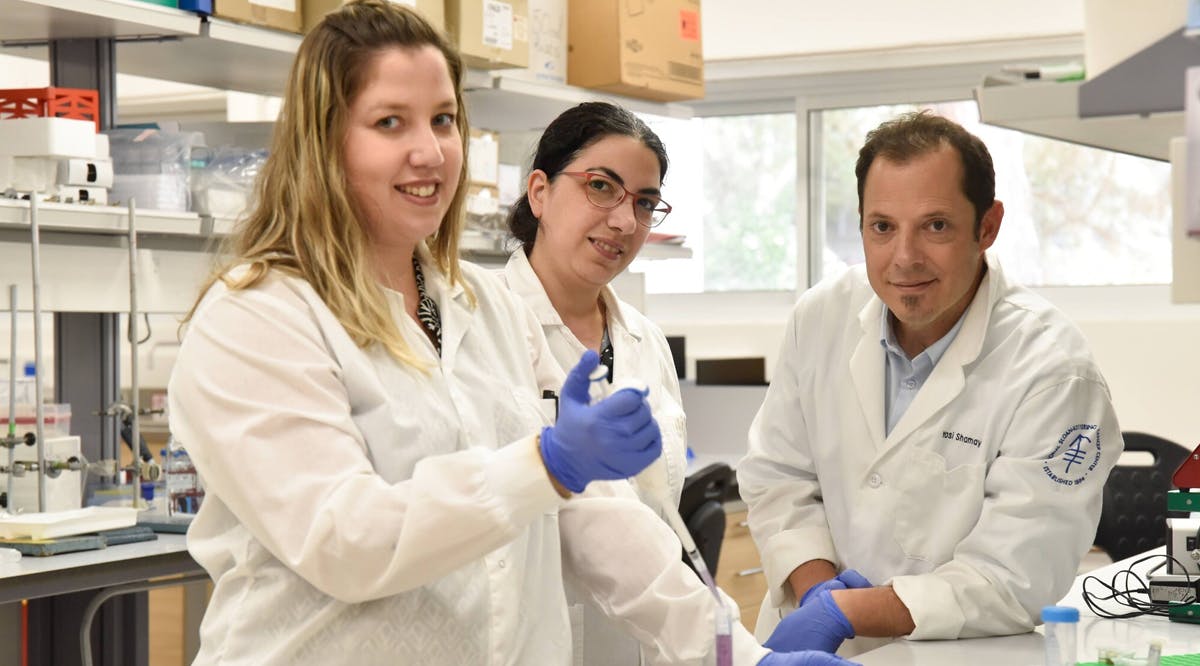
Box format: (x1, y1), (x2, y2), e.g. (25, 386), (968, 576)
(634, 113), (797, 293)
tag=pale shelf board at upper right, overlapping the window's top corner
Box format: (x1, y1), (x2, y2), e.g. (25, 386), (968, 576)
(974, 76), (1184, 161)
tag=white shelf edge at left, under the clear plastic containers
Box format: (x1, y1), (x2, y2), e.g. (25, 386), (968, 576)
(0, 199), (200, 235)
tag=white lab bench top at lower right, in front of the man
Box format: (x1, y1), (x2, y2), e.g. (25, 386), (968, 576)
(853, 547), (1200, 666)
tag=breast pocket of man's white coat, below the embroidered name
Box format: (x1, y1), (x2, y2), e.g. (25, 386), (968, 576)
(894, 449), (984, 563)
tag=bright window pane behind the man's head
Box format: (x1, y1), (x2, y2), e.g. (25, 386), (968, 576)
(811, 101), (1171, 286)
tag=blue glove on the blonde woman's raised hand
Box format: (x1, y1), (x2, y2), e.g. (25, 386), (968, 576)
(541, 349), (662, 492)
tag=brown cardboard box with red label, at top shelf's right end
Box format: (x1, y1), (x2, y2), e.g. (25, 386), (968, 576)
(566, 0), (704, 102)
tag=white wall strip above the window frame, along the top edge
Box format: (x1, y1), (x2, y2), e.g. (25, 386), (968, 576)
(702, 0), (1084, 61)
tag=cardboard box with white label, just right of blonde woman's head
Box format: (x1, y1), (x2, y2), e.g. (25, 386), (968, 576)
(446, 0), (529, 70)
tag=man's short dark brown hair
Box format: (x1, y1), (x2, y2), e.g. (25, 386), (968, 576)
(854, 109), (996, 236)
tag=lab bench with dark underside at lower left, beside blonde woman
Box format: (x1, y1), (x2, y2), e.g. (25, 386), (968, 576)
(0, 534), (204, 666)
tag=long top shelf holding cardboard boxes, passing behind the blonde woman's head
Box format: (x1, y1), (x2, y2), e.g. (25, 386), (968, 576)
(0, 0), (692, 115)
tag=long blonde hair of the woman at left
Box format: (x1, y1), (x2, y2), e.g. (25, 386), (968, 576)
(184, 0), (474, 367)
